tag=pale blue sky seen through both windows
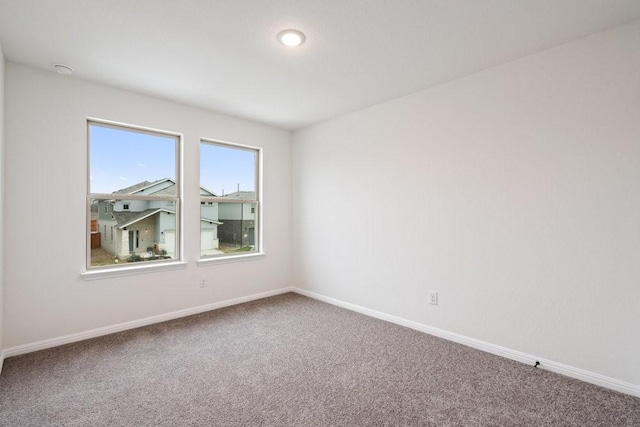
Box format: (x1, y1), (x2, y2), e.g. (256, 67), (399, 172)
(89, 125), (255, 195)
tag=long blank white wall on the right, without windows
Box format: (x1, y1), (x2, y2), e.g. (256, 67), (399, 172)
(293, 22), (640, 385)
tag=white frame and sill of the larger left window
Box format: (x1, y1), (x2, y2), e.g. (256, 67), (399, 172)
(81, 118), (186, 280)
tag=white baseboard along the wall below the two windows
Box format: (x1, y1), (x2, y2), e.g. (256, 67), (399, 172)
(2, 288), (294, 359)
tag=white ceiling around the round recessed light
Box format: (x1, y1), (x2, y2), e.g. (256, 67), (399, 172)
(0, 0), (640, 129)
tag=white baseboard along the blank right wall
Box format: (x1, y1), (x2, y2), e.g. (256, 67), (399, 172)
(292, 287), (640, 397)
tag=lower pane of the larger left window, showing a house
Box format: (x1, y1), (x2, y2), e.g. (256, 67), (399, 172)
(90, 199), (177, 267)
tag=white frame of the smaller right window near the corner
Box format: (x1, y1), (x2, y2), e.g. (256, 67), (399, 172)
(197, 138), (266, 266)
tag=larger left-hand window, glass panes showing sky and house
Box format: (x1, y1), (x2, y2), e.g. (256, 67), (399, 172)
(87, 120), (181, 269)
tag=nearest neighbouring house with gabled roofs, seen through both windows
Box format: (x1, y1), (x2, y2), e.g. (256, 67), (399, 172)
(92, 178), (222, 259)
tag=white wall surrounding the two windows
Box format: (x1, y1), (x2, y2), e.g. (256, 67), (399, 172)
(4, 62), (291, 348)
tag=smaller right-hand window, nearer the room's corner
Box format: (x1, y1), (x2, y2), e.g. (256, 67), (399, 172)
(200, 140), (262, 258)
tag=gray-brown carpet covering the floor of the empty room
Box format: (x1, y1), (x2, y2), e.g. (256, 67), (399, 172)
(0, 294), (640, 427)
